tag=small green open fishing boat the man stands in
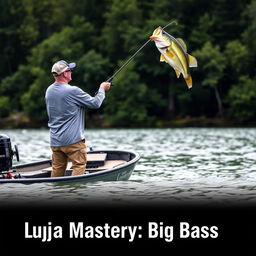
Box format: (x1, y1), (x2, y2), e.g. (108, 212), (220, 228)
(0, 150), (140, 184)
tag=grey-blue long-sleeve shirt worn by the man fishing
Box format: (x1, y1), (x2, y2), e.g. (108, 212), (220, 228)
(45, 82), (105, 146)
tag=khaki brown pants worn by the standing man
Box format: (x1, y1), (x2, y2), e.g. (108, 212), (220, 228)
(51, 141), (86, 177)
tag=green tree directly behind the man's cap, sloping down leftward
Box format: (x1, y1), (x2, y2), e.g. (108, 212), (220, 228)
(3, 17), (93, 120)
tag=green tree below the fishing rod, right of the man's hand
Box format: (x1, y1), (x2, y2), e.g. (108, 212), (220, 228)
(104, 63), (158, 126)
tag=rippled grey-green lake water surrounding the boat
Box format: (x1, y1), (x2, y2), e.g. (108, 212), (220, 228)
(0, 128), (256, 205)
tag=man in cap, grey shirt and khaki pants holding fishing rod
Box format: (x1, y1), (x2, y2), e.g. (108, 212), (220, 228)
(45, 60), (110, 177)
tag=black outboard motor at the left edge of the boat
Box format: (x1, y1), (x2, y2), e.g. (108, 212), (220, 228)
(0, 134), (20, 173)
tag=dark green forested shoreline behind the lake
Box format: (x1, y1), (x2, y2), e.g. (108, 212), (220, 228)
(0, 0), (256, 128)
